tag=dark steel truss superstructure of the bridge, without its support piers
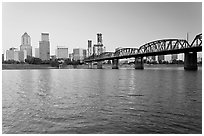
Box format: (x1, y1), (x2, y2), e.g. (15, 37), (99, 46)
(84, 33), (202, 62)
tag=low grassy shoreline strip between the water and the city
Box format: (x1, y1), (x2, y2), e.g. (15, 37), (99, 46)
(2, 64), (202, 70)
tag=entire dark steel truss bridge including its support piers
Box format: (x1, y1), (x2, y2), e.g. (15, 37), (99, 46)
(84, 33), (202, 70)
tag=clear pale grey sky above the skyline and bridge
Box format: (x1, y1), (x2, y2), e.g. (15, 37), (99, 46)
(2, 2), (202, 55)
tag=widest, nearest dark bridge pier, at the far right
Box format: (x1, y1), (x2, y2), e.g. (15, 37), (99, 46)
(184, 52), (198, 70)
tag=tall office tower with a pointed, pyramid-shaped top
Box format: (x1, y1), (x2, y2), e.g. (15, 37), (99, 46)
(20, 32), (32, 58)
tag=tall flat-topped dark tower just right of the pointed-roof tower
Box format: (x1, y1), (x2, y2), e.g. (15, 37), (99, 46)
(39, 33), (50, 60)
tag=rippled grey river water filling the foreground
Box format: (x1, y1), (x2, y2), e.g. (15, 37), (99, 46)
(2, 67), (202, 134)
